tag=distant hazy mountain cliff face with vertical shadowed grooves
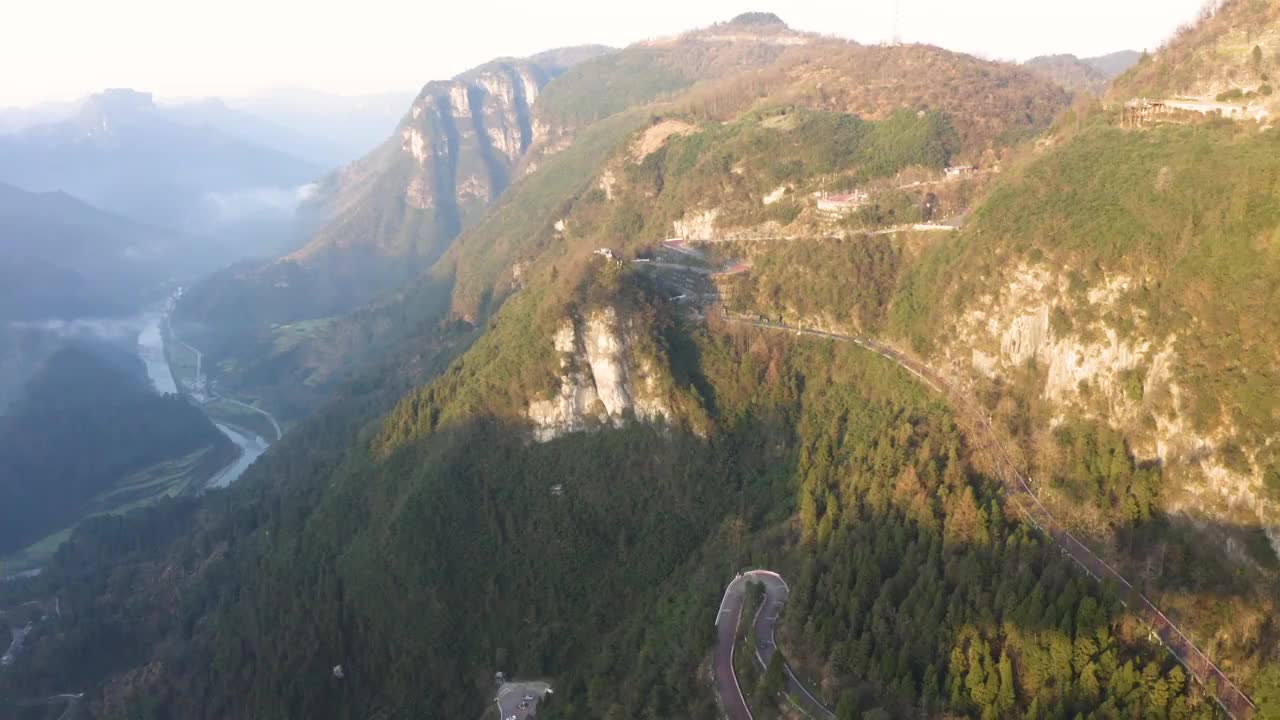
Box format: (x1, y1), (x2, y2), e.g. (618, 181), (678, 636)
(293, 60), (563, 280)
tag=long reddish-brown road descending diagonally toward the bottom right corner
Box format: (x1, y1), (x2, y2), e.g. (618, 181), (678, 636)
(722, 315), (1256, 720)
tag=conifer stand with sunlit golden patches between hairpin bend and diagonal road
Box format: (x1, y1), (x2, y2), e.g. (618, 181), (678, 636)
(787, 389), (1213, 717)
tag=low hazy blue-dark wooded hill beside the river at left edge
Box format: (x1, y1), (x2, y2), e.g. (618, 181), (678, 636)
(0, 346), (227, 552)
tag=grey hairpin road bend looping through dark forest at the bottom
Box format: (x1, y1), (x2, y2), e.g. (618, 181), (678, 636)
(714, 570), (836, 720)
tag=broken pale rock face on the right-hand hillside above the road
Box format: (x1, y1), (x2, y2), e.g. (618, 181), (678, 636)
(933, 265), (1280, 553)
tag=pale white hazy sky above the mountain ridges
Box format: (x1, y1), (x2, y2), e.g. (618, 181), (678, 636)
(0, 0), (1204, 105)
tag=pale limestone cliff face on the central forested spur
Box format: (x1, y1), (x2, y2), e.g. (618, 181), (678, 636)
(529, 307), (672, 442)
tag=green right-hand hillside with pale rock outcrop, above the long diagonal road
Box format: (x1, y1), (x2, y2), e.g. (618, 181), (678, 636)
(890, 118), (1280, 691)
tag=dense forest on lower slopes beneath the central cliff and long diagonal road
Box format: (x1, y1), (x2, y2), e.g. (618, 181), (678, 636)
(0, 294), (1249, 717)
